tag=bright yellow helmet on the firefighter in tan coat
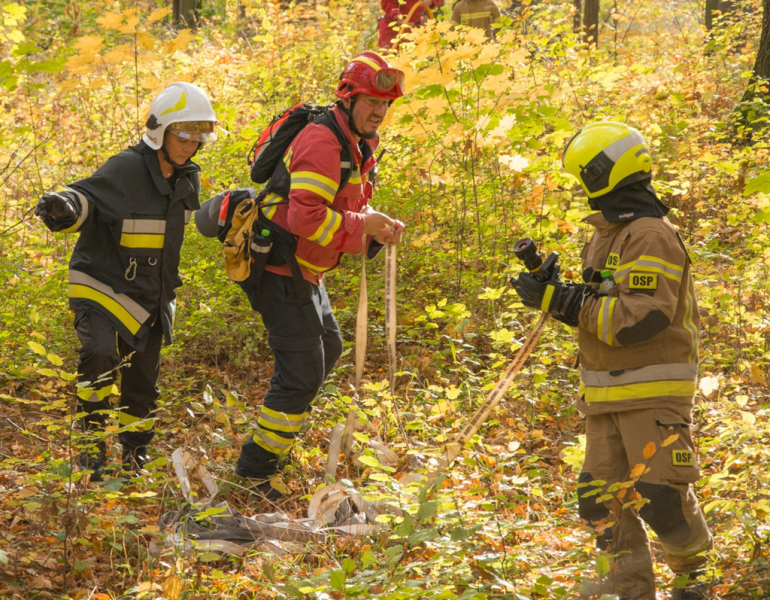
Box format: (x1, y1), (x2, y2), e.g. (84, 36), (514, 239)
(561, 121), (652, 198)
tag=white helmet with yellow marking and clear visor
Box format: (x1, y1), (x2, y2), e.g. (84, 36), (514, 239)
(142, 81), (217, 150)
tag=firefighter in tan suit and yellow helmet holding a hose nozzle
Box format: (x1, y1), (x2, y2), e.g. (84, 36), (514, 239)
(514, 122), (712, 600)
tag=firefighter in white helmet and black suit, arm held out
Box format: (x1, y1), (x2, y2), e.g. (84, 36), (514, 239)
(35, 82), (217, 481)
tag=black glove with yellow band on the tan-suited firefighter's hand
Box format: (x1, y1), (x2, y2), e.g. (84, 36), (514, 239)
(511, 272), (598, 327)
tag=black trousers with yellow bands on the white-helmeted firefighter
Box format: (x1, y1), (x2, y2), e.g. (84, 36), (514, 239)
(75, 309), (163, 448)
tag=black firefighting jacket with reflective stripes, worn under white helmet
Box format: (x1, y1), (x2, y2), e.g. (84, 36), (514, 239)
(54, 142), (200, 351)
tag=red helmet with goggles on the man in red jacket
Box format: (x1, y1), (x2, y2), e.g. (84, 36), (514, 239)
(334, 51), (404, 100)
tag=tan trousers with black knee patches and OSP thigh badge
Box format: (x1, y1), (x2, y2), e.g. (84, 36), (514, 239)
(578, 406), (713, 600)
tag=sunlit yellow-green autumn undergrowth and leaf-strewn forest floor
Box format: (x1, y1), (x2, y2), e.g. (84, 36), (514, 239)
(0, 0), (770, 600)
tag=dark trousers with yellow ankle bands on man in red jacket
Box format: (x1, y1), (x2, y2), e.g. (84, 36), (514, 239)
(236, 271), (342, 479)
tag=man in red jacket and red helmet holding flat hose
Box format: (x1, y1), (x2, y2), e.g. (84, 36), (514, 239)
(236, 52), (404, 498)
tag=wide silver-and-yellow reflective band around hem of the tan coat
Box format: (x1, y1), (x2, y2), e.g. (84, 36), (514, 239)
(580, 363), (698, 402)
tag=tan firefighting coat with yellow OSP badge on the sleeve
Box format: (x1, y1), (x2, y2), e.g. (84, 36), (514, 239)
(579, 213), (700, 414)
